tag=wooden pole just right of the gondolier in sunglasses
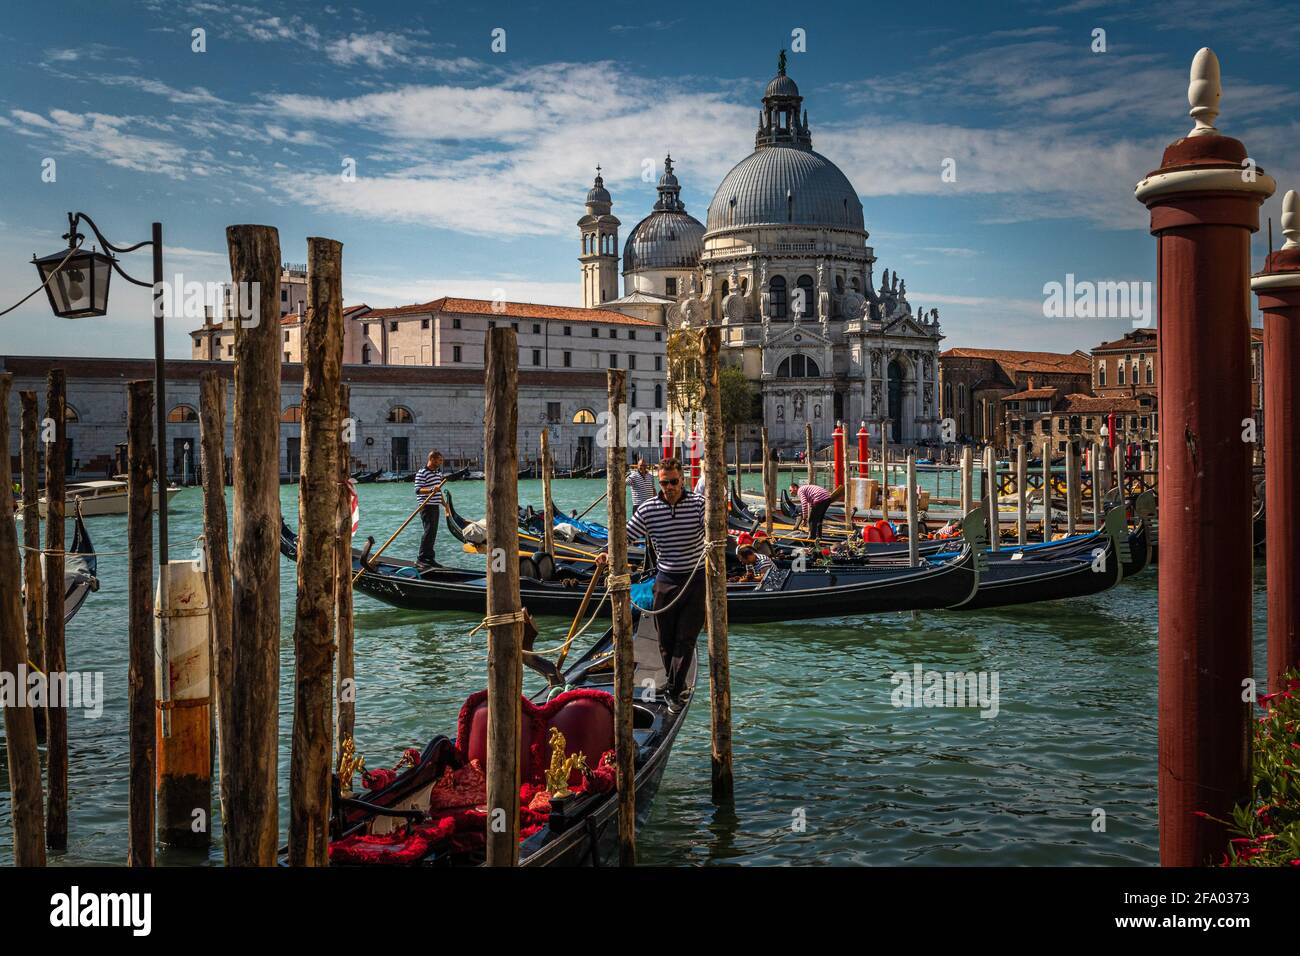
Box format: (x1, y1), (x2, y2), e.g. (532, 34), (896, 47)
(699, 326), (735, 803)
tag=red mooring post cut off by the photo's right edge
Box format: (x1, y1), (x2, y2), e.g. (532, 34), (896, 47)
(1251, 190), (1300, 692)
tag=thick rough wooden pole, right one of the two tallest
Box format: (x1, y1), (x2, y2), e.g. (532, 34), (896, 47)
(289, 237), (343, 866)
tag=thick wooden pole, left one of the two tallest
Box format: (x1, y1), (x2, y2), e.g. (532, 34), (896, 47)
(226, 225), (281, 866)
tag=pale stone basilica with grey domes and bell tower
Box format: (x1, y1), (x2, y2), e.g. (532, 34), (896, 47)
(579, 53), (943, 449)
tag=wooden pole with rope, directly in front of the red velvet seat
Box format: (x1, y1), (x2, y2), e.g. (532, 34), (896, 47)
(484, 328), (520, 866)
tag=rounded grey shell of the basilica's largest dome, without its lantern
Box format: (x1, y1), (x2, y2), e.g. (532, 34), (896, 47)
(707, 147), (866, 233)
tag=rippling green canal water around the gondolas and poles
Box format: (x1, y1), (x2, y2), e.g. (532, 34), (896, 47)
(0, 475), (1265, 865)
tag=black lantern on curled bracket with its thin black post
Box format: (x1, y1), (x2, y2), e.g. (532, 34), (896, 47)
(31, 212), (168, 567)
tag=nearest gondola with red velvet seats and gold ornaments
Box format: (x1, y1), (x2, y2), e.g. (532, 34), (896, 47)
(313, 615), (698, 866)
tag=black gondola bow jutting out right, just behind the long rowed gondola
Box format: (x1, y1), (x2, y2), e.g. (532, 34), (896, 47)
(930, 509), (1128, 611)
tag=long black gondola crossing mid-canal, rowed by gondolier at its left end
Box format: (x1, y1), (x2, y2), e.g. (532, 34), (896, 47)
(292, 510), (983, 623)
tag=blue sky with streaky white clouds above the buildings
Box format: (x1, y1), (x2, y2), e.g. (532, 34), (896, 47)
(0, 0), (1300, 356)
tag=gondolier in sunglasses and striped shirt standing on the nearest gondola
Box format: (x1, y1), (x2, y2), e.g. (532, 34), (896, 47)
(597, 458), (705, 713)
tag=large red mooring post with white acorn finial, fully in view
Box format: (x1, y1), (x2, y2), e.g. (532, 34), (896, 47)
(1133, 48), (1274, 866)
